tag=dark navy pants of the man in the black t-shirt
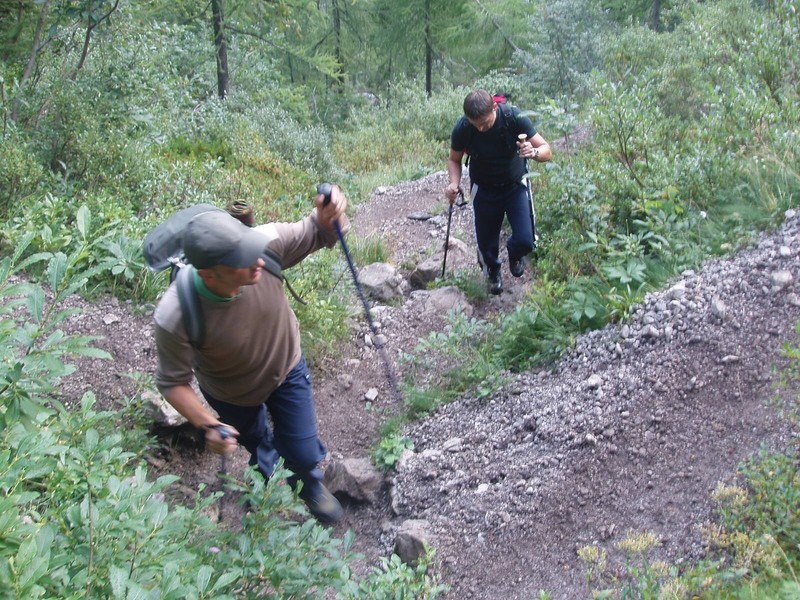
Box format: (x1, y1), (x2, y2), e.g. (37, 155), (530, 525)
(472, 183), (534, 271)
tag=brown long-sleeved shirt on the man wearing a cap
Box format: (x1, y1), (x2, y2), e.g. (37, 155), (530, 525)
(154, 213), (348, 406)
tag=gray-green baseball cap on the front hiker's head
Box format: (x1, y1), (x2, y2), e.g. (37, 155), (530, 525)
(183, 210), (268, 269)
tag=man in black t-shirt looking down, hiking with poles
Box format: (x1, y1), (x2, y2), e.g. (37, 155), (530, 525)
(445, 89), (553, 294)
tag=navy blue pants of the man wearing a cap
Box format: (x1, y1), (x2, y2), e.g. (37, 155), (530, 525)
(201, 358), (327, 489)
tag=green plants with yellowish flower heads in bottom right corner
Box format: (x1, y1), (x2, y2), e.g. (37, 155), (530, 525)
(578, 450), (800, 600)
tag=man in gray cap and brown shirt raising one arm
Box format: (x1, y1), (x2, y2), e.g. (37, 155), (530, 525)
(155, 186), (349, 523)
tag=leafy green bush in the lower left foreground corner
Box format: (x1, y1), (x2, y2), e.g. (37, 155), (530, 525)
(0, 230), (442, 598)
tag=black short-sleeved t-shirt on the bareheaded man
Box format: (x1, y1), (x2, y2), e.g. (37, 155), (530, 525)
(450, 105), (536, 187)
